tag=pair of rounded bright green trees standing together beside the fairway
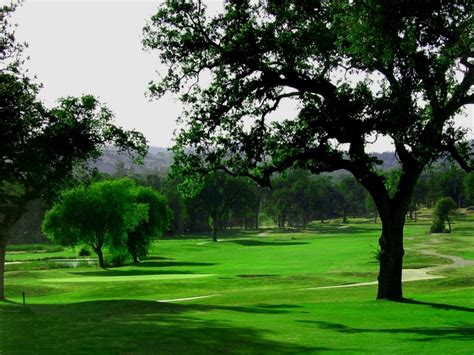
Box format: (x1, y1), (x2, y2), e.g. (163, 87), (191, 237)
(42, 179), (171, 268)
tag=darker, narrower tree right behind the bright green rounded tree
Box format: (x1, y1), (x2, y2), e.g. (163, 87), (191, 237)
(126, 187), (172, 263)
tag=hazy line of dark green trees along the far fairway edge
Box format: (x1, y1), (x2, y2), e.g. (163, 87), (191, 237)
(112, 161), (474, 240)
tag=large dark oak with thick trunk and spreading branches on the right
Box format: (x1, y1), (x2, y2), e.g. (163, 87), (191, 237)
(144, 0), (474, 300)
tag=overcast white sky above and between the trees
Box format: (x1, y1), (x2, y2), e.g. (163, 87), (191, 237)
(8, 0), (474, 151)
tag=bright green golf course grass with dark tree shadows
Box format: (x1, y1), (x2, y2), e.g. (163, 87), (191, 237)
(0, 215), (474, 354)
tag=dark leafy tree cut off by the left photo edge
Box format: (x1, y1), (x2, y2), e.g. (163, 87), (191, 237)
(0, 5), (146, 300)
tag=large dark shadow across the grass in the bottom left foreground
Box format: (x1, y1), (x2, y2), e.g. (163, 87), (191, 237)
(0, 300), (320, 354)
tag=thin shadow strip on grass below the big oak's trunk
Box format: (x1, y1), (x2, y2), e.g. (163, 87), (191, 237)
(298, 320), (474, 341)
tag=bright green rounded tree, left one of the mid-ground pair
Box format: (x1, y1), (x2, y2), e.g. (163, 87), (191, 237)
(42, 179), (149, 268)
